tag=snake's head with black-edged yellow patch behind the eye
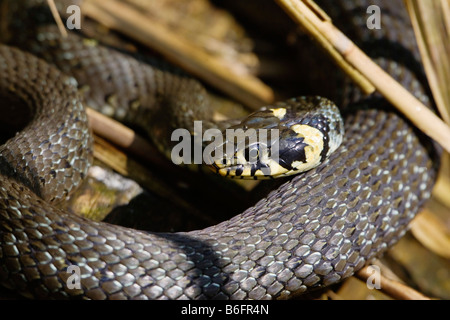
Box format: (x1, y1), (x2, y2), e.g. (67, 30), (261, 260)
(206, 97), (344, 179)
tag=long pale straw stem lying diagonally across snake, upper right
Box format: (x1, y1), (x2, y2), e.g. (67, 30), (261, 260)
(276, 0), (450, 152)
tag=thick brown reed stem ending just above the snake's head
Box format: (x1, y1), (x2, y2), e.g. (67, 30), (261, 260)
(83, 0), (273, 108)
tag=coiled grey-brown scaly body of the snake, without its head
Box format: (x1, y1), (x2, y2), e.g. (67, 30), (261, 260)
(0, 1), (438, 300)
